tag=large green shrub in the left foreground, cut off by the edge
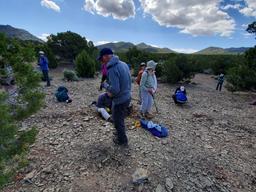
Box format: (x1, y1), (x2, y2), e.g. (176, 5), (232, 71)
(0, 34), (44, 188)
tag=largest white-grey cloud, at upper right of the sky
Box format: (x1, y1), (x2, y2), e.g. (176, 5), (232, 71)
(140, 0), (235, 36)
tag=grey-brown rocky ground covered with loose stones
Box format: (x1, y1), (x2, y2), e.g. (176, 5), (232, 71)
(3, 74), (256, 192)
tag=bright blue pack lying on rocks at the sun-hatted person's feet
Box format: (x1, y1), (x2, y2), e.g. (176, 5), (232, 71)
(140, 119), (168, 138)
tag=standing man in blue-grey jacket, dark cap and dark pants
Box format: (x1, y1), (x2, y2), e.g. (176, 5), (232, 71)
(97, 48), (131, 146)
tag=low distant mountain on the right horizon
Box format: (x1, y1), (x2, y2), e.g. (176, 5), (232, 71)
(194, 47), (250, 55)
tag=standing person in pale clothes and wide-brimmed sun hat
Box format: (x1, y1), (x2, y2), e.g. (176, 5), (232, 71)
(140, 60), (157, 119)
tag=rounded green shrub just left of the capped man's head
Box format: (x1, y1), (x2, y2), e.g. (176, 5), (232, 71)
(75, 50), (95, 77)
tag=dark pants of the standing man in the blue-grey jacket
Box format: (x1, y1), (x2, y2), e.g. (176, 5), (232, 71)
(112, 99), (131, 144)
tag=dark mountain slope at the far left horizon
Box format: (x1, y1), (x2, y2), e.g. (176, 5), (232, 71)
(0, 25), (44, 43)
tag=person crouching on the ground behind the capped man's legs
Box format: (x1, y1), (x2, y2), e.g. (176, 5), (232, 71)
(92, 92), (113, 122)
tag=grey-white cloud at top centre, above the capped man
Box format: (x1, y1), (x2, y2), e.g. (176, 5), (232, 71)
(84, 0), (135, 20)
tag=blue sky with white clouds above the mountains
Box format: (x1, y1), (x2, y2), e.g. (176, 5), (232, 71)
(0, 0), (256, 52)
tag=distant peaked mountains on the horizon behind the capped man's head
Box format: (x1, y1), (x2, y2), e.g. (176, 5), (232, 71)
(97, 41), (176, 53)
